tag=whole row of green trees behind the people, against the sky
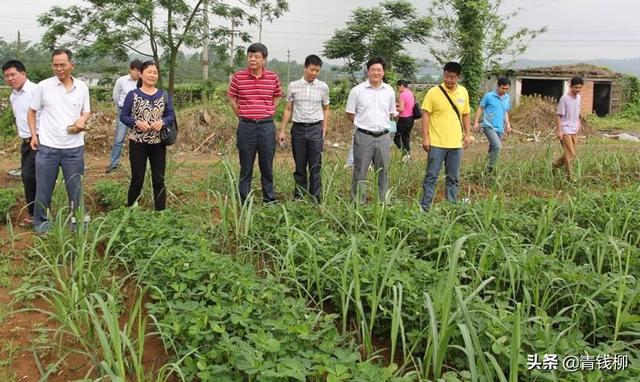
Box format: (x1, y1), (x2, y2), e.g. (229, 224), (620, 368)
(7, 0), (545, 103)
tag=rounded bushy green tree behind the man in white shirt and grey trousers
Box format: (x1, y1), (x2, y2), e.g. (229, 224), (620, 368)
(323, 0), (432, 82)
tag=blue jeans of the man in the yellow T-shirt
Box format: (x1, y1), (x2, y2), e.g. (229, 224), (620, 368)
(420, 146), (463, 211)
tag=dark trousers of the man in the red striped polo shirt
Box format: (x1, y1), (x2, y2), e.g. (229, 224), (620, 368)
(236, 121), (276, 203)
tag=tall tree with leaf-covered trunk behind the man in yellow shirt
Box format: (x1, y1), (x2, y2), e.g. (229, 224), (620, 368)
(429, 0), (546, 104)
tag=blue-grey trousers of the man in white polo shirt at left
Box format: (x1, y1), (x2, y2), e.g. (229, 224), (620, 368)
(33, 145), (84, 232)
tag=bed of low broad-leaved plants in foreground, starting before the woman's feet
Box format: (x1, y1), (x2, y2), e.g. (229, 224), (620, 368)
(100, 210), (399, 381)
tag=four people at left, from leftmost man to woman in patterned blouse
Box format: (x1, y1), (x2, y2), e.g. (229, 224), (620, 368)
(2, 49), (175, 233)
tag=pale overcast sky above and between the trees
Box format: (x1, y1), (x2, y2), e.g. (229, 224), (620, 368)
(0, 0), (640, 62)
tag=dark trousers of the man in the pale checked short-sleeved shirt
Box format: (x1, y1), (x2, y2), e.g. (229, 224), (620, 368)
(291, 122), (323, 201)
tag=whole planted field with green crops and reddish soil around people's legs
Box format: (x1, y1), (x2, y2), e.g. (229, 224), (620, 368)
(0, 115), (640, 381)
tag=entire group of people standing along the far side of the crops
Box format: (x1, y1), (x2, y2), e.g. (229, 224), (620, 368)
(2, 43), (583, 232)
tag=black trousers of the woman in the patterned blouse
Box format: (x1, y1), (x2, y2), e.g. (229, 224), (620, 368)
(127, 141), (167, 211)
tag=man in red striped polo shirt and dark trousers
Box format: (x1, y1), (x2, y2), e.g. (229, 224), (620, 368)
(227, 43), (282, 203)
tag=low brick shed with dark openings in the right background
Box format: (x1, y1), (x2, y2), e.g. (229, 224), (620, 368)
(484, 64), (623, 117)
